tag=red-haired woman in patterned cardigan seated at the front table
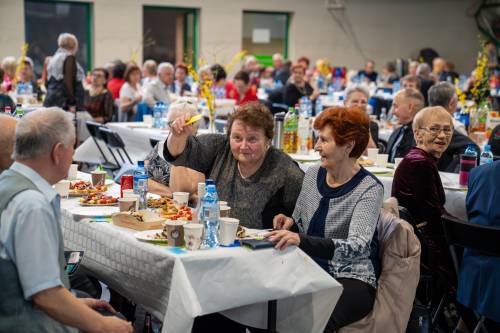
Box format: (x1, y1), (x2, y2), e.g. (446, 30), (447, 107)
(267, 107), (384, 332)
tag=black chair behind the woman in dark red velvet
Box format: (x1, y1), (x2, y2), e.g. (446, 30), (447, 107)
(441, 215), (500, 333)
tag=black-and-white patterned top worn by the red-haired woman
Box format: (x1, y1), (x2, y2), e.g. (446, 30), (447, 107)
(293, 165), (384, 287)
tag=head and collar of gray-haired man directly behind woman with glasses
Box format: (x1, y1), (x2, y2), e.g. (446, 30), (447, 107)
(429, 82), (467, 135)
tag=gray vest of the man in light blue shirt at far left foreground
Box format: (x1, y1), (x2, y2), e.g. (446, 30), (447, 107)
(0, 170), (76, 333)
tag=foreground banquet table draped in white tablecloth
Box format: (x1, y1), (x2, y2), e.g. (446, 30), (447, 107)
(61, 173), (342, 333)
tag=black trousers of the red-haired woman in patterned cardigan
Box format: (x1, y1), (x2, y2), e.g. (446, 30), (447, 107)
(325, 278), (377, 333)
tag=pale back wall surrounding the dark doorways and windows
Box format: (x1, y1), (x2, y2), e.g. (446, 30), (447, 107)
(0, 0), (478, 72)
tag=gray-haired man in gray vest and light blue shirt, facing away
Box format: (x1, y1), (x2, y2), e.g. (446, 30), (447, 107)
(0, 109), (132, 333)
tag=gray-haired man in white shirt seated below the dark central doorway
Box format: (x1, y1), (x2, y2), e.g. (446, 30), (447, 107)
(144, 62), (174, 108)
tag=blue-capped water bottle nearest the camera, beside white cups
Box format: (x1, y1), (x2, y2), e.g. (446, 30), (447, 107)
(200, 185), (219, 248)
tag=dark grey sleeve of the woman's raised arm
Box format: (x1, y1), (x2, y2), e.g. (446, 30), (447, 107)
(163, 134), (229, 177)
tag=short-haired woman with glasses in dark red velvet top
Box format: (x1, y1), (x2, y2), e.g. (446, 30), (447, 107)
(392, 106), (453, 290)
